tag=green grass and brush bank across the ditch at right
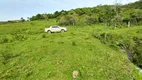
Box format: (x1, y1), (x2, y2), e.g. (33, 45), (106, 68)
(94, 26), (142, 68)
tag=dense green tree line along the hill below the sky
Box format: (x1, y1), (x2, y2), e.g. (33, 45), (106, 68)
(29, 0), (142, 27)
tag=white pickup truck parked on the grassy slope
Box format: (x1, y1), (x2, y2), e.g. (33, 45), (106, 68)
(44, 26), (67, 33)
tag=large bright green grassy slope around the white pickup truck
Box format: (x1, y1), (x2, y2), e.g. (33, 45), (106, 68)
(0, 20), (140, 80)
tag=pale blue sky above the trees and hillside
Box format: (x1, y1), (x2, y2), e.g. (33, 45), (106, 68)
(0, 0), (137, 21)
